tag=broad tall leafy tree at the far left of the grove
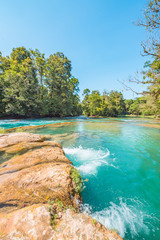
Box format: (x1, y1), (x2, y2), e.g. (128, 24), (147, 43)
(1, 47), (38, 116)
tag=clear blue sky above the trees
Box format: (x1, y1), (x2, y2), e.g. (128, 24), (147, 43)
(0, 0), (147, 98)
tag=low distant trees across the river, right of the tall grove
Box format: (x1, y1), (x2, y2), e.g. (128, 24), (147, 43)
(82, 89), (160, 117)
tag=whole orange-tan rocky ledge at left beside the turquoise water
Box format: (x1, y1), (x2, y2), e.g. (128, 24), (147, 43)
(0, 132), (122, 240)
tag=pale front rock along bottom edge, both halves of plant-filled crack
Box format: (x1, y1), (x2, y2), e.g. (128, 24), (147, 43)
(0, 205), (122, 240)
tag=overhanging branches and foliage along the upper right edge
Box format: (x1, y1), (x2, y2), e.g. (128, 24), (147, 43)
(138, 0), (160, 115)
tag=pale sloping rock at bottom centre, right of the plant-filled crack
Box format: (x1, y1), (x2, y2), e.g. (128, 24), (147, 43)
(53, 209), (122, 240)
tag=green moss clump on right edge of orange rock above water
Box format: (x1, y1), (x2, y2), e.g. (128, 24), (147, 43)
(71, 168), (83, 194)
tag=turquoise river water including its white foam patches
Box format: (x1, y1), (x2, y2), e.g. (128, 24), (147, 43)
(0, 118), (160, 240)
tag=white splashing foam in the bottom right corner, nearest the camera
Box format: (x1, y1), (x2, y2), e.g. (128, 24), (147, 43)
(82, 199), (159, 239)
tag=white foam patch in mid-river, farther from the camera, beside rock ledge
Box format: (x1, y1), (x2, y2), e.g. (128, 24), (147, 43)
(64, 146), (114, 175)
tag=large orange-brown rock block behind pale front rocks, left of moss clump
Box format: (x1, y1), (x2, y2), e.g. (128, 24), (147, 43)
(0, 163), (75, 212)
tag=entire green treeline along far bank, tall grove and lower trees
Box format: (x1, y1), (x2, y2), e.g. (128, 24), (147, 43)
(0, 47), (160, 118)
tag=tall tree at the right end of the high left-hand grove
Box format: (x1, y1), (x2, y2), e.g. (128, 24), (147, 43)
(46, 52), (71, 116)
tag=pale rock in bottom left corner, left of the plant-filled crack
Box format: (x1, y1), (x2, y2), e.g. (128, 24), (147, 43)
(0, 205), (54, 240)
